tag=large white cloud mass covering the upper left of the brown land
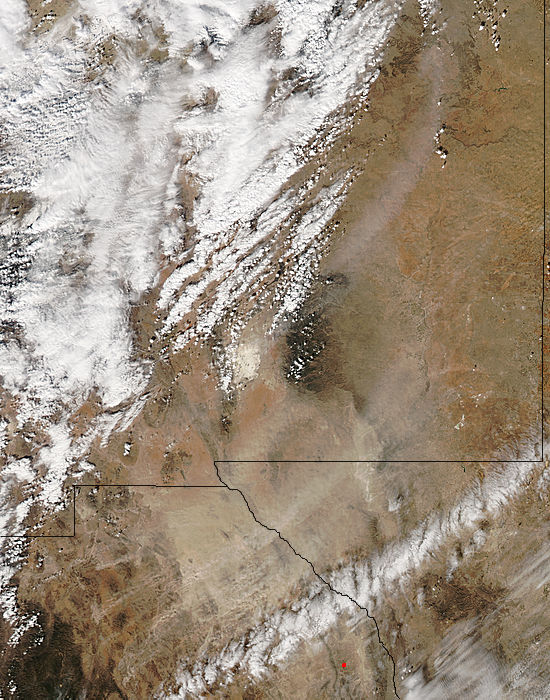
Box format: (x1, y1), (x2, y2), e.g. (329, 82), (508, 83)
(0, 0), (414, 636)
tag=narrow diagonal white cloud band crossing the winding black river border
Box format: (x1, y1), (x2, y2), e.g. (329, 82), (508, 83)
(162, 454), (539, 700)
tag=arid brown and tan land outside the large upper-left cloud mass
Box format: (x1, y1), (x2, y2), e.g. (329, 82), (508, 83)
(0, 0), (550, 700)
